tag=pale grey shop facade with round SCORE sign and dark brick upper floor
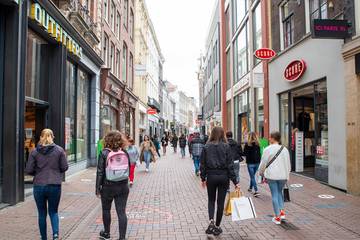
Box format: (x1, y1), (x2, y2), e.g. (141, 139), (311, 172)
(269, 0), (359, 193)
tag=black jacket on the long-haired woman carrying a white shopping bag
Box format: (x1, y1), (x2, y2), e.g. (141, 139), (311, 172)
(200, 142), (238, 185)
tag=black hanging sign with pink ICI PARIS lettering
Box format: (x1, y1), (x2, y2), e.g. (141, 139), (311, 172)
(312, 19), (350, 39)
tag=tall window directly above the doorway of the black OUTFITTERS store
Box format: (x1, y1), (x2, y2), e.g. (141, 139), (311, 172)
(25, 29), (49, 101)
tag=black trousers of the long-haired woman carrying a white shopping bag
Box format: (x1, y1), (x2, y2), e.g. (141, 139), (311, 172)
(207, 175), (229, 226)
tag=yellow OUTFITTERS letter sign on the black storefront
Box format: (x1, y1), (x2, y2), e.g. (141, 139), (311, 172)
(30, 3), (82, 58)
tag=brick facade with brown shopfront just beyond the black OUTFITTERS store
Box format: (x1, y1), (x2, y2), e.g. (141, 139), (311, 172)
(99, 0), (138, 139)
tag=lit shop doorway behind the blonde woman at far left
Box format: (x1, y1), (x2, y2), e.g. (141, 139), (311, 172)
(24, 99), (48, 184)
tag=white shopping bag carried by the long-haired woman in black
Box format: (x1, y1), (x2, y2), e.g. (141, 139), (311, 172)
(231, 197), (256, 222)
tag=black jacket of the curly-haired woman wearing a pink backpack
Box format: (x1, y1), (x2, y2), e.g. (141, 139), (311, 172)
(95, 149), (130, 194)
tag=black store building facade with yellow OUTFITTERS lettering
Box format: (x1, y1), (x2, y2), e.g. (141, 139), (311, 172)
(0, 0), (103, 204)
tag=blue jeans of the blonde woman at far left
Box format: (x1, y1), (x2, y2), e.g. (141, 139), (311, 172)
(34, 185), (61, 240)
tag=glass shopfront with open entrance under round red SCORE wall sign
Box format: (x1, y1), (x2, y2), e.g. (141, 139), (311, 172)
(279, 81), (328, 182)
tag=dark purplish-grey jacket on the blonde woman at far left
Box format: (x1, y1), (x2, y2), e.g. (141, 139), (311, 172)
(25, 144), (69, 185)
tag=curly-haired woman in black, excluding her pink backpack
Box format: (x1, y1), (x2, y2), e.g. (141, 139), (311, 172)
(96, 131), (130, 240)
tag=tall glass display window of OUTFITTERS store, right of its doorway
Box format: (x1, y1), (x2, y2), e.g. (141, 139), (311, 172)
(65, 61), (90, 162)
